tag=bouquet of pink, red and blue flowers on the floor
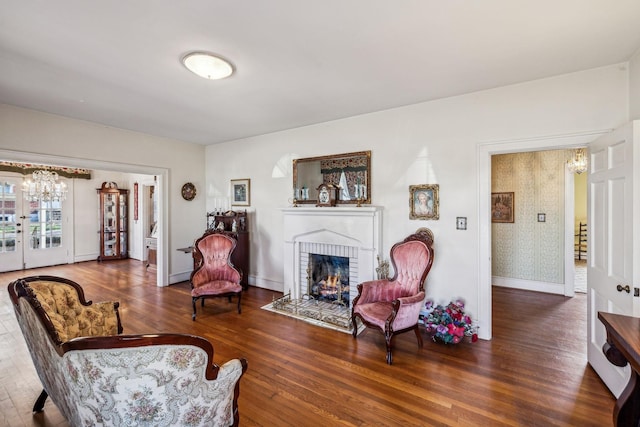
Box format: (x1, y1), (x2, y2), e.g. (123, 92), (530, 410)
(424, 300), (478, 344)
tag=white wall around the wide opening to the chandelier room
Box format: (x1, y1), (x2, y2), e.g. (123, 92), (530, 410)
(0, 105), (206, 284)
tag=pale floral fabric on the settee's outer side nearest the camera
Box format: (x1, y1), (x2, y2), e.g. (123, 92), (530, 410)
(64, 345), (242, 426)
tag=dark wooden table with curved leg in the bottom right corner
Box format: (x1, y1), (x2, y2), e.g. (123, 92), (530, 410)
(598, 311), (640, 427)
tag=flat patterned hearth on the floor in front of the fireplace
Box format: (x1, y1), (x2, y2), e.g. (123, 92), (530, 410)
(262, 294), (364, 334)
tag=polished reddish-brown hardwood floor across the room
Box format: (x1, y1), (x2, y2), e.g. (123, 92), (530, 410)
(0, 260), (614, 426)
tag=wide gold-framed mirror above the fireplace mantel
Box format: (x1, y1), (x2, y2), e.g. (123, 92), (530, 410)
(293, 151), (371, 204)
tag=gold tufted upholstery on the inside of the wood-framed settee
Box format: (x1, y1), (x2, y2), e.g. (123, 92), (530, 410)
(29, 281), (118, 342)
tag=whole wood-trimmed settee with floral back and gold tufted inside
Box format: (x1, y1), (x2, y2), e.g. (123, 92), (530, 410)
(8, 276), (247, 426)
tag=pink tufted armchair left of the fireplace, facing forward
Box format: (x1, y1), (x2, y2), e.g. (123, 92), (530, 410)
(189, 230), (242, 320)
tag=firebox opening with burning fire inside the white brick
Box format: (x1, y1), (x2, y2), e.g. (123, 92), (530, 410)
(307, 253), (350, 307)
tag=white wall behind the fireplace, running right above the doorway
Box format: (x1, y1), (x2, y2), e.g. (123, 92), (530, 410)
(206, 65), (628, 332)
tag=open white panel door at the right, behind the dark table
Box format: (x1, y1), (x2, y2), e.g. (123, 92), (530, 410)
(587, 122), (640, 397)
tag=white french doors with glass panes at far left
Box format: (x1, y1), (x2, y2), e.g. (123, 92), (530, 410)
(0, 176), (70, 272)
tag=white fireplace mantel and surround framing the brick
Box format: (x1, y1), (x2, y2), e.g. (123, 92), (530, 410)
(282, 206), (382, 298)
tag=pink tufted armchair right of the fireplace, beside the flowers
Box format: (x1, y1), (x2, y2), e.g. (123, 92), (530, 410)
(351, 228), (433, 365)
